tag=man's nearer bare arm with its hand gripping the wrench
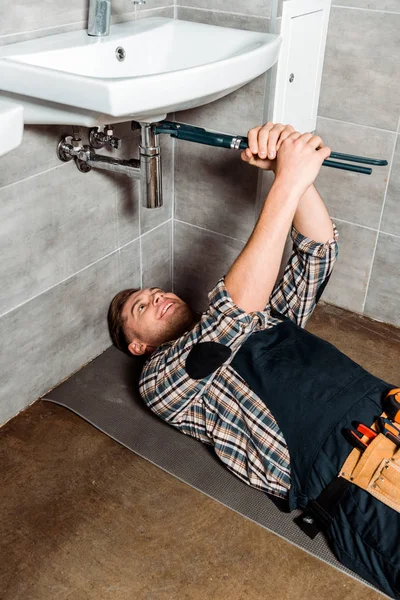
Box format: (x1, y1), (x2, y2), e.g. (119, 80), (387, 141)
(225, 126), (332, 312)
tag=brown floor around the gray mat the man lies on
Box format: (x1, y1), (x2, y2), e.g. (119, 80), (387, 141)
(0, 305), (400, 600)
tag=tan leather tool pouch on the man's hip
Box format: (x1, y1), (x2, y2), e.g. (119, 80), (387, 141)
(339, 433), (400, 512)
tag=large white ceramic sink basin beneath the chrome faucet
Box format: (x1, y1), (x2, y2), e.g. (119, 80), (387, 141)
(0, 17), (281, 126)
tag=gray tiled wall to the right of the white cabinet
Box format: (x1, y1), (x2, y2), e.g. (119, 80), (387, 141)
(316, 0), (400, 326)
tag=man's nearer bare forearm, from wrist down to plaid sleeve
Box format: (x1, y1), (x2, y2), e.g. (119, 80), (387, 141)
(225, 181), (300, 312)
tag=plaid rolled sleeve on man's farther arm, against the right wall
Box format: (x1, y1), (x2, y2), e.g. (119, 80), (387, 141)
(270, 223), (339, 327)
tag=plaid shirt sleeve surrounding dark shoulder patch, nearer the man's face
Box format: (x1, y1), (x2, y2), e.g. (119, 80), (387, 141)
(139, 278), (269, 432)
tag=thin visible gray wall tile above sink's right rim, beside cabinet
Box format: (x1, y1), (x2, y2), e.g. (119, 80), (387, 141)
(177, 6), (270, 33)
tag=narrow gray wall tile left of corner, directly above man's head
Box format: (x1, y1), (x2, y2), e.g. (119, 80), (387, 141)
(141, 221), (172, 292)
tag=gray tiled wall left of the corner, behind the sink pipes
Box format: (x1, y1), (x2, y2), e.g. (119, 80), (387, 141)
(0, 0), (174, 424)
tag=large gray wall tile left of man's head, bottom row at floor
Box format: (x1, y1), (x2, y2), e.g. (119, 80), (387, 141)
(0, 241), (140, 423)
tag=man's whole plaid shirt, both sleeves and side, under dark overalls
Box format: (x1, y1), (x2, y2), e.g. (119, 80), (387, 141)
(139, 225), (338, 498)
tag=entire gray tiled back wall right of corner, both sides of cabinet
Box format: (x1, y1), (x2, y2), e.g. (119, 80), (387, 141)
(174, 0), (400, 332)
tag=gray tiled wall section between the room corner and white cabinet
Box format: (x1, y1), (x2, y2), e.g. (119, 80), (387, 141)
(173, 0), (272, 310)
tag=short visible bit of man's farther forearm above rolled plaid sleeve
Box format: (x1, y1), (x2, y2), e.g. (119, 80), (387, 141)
(293, 184), (333, 242)
